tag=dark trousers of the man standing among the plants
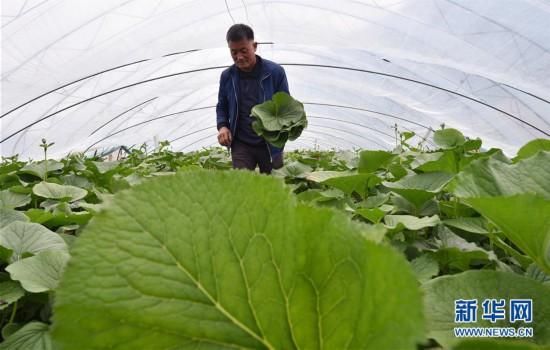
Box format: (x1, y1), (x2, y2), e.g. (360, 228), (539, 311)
(231, 139), (283, 174)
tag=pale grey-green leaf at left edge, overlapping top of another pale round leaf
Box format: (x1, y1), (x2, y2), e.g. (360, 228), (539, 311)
(0, 221), (67, 261)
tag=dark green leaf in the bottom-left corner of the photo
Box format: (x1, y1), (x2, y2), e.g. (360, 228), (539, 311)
(0, 322), (52, 350)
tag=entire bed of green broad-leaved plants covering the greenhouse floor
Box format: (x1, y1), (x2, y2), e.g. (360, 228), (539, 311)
(0, 130), (550, 350)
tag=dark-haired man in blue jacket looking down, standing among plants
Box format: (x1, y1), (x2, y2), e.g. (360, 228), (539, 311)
(216, 24), (289, 174)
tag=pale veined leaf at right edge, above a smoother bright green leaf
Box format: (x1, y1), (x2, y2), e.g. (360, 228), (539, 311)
(454, 152), (550, 200)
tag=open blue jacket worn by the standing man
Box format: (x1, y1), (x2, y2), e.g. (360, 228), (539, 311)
(216, 58), (290, 157)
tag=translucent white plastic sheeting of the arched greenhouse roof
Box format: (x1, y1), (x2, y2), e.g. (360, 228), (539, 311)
(0, 0), (550, 158)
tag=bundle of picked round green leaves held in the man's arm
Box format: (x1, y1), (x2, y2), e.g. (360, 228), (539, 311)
(251, 92), (307, 148)
